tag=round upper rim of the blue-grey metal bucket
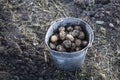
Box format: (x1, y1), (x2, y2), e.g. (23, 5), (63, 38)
(45, 17), (94, 55)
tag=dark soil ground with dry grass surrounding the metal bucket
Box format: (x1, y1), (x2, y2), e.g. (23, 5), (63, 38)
(0, 0), (120, 80)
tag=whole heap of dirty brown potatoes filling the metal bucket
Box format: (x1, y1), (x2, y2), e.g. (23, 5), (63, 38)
(49, 25), (88, 52)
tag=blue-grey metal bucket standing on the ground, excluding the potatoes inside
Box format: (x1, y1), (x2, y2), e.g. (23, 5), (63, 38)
(45, 17), (94, 71)
